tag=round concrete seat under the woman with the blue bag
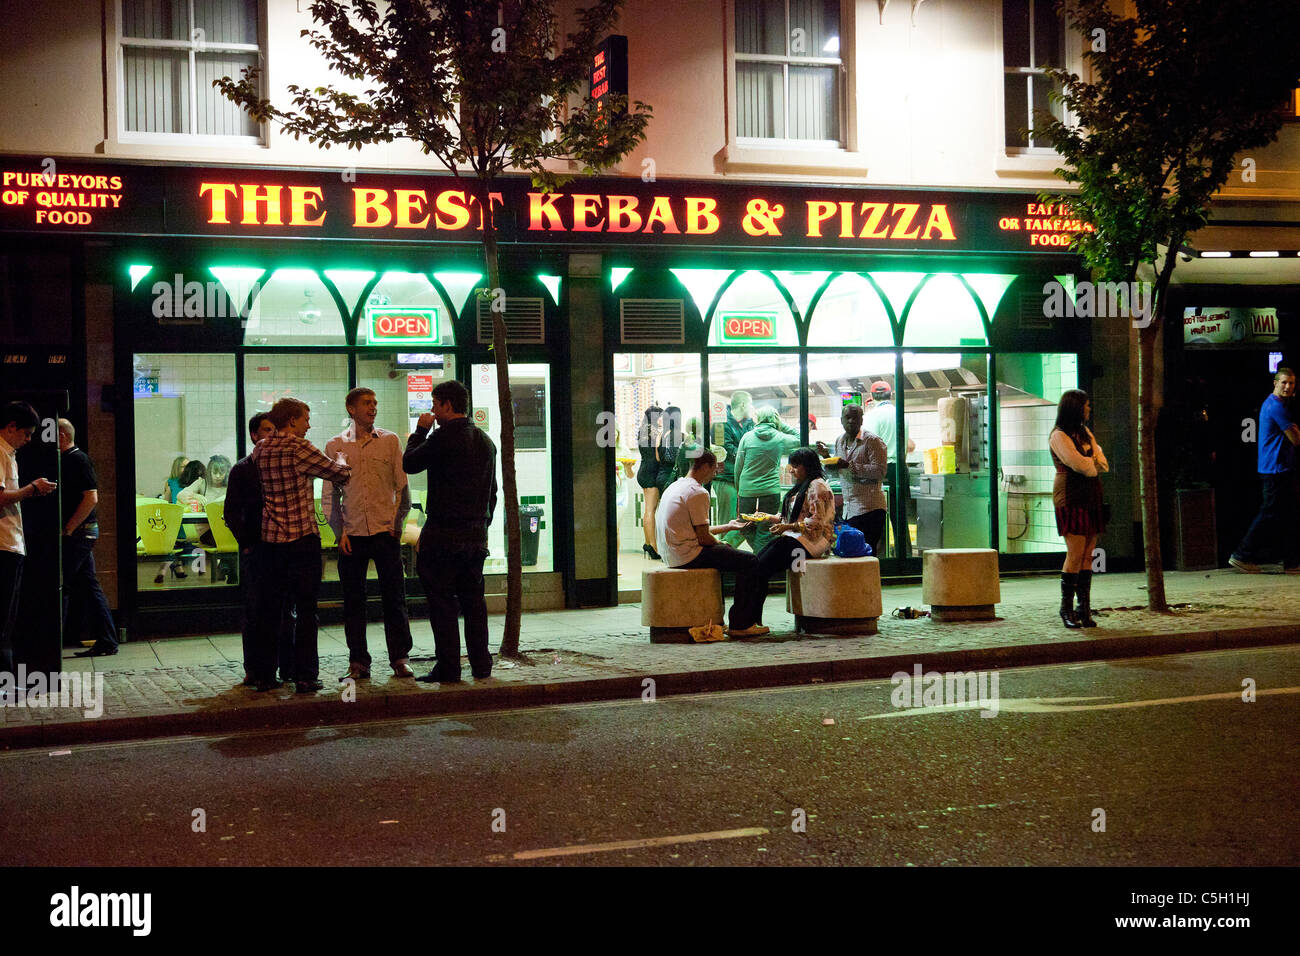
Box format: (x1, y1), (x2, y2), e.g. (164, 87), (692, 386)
(785, 555), (881, 636)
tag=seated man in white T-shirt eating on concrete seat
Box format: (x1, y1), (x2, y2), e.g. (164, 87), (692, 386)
(655, 449), (768, 637)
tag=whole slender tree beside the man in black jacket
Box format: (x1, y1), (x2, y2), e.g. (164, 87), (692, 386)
(213, 0), (651, 657)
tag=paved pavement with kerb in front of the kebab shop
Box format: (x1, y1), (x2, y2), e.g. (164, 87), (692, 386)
(0, 570), (1300, 749)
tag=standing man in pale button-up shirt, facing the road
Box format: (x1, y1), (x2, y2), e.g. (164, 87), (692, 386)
(322, 388), (415, 680)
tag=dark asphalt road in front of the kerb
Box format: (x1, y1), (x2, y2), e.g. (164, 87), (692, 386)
(0, 646), (1300, 866)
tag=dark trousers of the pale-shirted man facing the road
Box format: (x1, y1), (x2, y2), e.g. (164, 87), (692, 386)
(338, 532), (411, 667)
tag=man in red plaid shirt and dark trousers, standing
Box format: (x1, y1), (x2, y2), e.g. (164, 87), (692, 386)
(251, 398), (352, 693)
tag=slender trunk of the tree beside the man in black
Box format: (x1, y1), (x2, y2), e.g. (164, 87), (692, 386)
(476, 181), (524, 658)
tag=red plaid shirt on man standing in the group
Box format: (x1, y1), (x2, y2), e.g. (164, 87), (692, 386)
(250, 433), (352, 544)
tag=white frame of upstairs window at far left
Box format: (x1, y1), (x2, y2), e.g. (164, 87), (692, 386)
(108, 0), (269, 150)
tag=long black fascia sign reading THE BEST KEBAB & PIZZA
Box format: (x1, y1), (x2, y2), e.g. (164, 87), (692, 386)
(0, 153), (1087, 254)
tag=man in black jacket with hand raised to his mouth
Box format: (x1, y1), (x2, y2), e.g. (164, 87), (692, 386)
(402, 381), (497, 684)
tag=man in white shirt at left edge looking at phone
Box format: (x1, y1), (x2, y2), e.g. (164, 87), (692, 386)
(0, 402), (57, 674)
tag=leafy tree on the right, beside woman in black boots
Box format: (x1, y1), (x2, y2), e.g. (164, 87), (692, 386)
(1035, 0), (1300, 611)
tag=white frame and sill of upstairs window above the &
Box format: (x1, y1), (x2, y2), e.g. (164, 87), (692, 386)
(719, 0), (867, 177)
